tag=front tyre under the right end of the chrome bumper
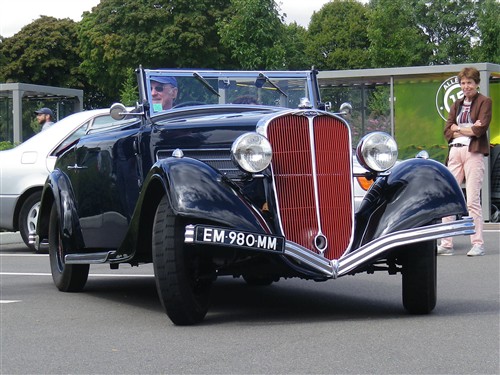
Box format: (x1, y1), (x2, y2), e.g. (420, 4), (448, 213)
(402, 240), (437, 314)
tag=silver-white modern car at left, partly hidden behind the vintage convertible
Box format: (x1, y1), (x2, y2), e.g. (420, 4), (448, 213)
(0, 108), (133, 249)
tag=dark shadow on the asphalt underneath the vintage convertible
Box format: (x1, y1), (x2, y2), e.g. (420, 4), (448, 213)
(82, 276), (406, 325)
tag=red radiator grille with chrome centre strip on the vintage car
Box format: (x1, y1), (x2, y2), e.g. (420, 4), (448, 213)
(268, 115), (353, 259)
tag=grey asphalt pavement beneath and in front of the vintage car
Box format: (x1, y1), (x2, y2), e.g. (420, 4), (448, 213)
(0, 224), (500, 375)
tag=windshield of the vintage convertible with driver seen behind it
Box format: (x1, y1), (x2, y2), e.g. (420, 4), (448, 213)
(143, 70), (312, 115)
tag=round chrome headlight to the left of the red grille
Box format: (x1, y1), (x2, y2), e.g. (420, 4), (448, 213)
(231, 133), (272, 173)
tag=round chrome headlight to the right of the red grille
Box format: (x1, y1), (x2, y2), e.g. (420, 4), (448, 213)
(356, 132), (398, 172)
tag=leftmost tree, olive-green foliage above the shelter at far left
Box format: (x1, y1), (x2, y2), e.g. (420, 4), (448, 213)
(0, 16), (83, 88)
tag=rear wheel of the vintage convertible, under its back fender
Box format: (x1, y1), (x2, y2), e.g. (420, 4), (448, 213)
(49, 204), (89, 292)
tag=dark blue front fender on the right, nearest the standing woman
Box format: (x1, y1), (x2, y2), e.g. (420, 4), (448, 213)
(356, 159), (467, 244)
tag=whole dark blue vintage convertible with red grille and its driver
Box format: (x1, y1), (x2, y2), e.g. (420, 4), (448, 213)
(34, 68), (474, 325)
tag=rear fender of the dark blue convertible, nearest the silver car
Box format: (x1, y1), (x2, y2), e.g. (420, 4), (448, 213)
(37, 169), (84, 251)
